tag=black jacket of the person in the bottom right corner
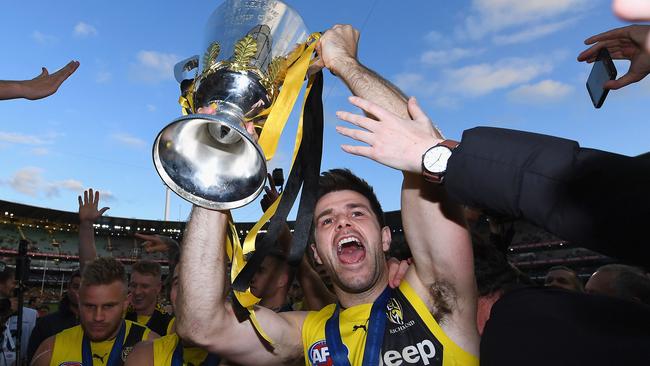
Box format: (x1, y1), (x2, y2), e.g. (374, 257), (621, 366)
(481, 288), (650, 366)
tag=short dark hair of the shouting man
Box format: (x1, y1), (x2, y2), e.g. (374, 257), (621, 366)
(316, 169), (385, 227)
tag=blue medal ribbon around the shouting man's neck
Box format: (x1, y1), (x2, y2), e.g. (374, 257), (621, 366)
(325, 287), (392, 366)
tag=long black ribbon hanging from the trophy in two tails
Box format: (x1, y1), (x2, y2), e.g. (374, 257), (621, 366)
(232, 72), (323, 291)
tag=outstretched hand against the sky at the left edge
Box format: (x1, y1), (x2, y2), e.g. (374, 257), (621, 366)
(0, 61), (79, 100)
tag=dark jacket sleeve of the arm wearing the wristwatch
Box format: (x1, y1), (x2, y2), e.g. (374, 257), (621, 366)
(445, 127), (650, 266)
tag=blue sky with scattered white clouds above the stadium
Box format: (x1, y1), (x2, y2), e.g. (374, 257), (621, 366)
(0, 0), (650, 221)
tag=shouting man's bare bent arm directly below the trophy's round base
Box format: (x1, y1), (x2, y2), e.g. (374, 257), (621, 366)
(176, 207), (305, 365)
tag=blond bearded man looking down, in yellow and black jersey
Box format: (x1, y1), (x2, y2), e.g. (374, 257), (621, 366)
(32, 258), (157, 366)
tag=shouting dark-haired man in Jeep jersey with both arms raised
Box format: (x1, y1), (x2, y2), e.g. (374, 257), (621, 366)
(176, 25), (479, 366)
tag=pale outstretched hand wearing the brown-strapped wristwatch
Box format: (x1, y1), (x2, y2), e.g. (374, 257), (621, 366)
(336, 97), (442, 174)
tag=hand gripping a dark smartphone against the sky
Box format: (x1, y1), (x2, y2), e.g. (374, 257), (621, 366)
(578, 25), (650, 90)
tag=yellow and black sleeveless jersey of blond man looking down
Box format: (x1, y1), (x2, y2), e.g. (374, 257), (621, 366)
(50, 320), (150, 366)
